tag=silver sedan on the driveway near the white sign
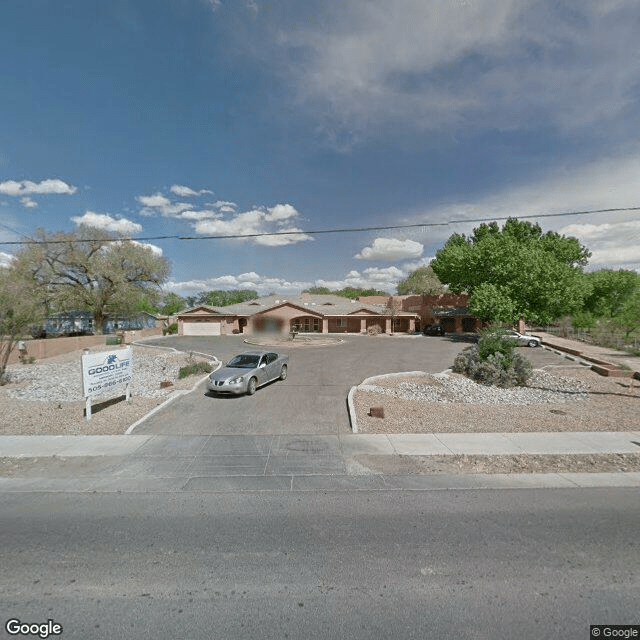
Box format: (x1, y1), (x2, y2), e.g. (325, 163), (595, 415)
(207, 353), (289, 395)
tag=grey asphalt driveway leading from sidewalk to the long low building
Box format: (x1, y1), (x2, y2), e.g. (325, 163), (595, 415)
(135, 335), (558, 435)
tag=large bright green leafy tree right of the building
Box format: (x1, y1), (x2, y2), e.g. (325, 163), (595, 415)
(431, 218), (591, 324)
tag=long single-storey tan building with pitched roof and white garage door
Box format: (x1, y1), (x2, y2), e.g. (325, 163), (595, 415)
(178, 293), (420, 336)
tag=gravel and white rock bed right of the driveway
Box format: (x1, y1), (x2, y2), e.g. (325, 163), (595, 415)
(353, 365), (640, 433)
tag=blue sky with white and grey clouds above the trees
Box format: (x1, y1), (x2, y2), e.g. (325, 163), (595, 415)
(0, 0), (640, 296)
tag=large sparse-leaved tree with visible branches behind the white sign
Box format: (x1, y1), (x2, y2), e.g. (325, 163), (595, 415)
(16, 226), (170, 332)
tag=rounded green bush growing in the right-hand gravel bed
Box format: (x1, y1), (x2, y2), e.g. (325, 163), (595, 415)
(453, 328), (533, 387)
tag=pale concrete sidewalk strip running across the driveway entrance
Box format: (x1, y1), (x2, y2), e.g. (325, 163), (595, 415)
(0, 429), (640, 458)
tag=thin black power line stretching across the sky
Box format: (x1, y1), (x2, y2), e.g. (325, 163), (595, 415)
(0, 207), (640, 245)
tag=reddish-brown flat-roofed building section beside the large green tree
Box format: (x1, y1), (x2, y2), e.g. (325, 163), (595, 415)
(358, 293), (482, 333)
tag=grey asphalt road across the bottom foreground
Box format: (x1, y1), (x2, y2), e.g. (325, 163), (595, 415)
(0, 489), (640, 640)
